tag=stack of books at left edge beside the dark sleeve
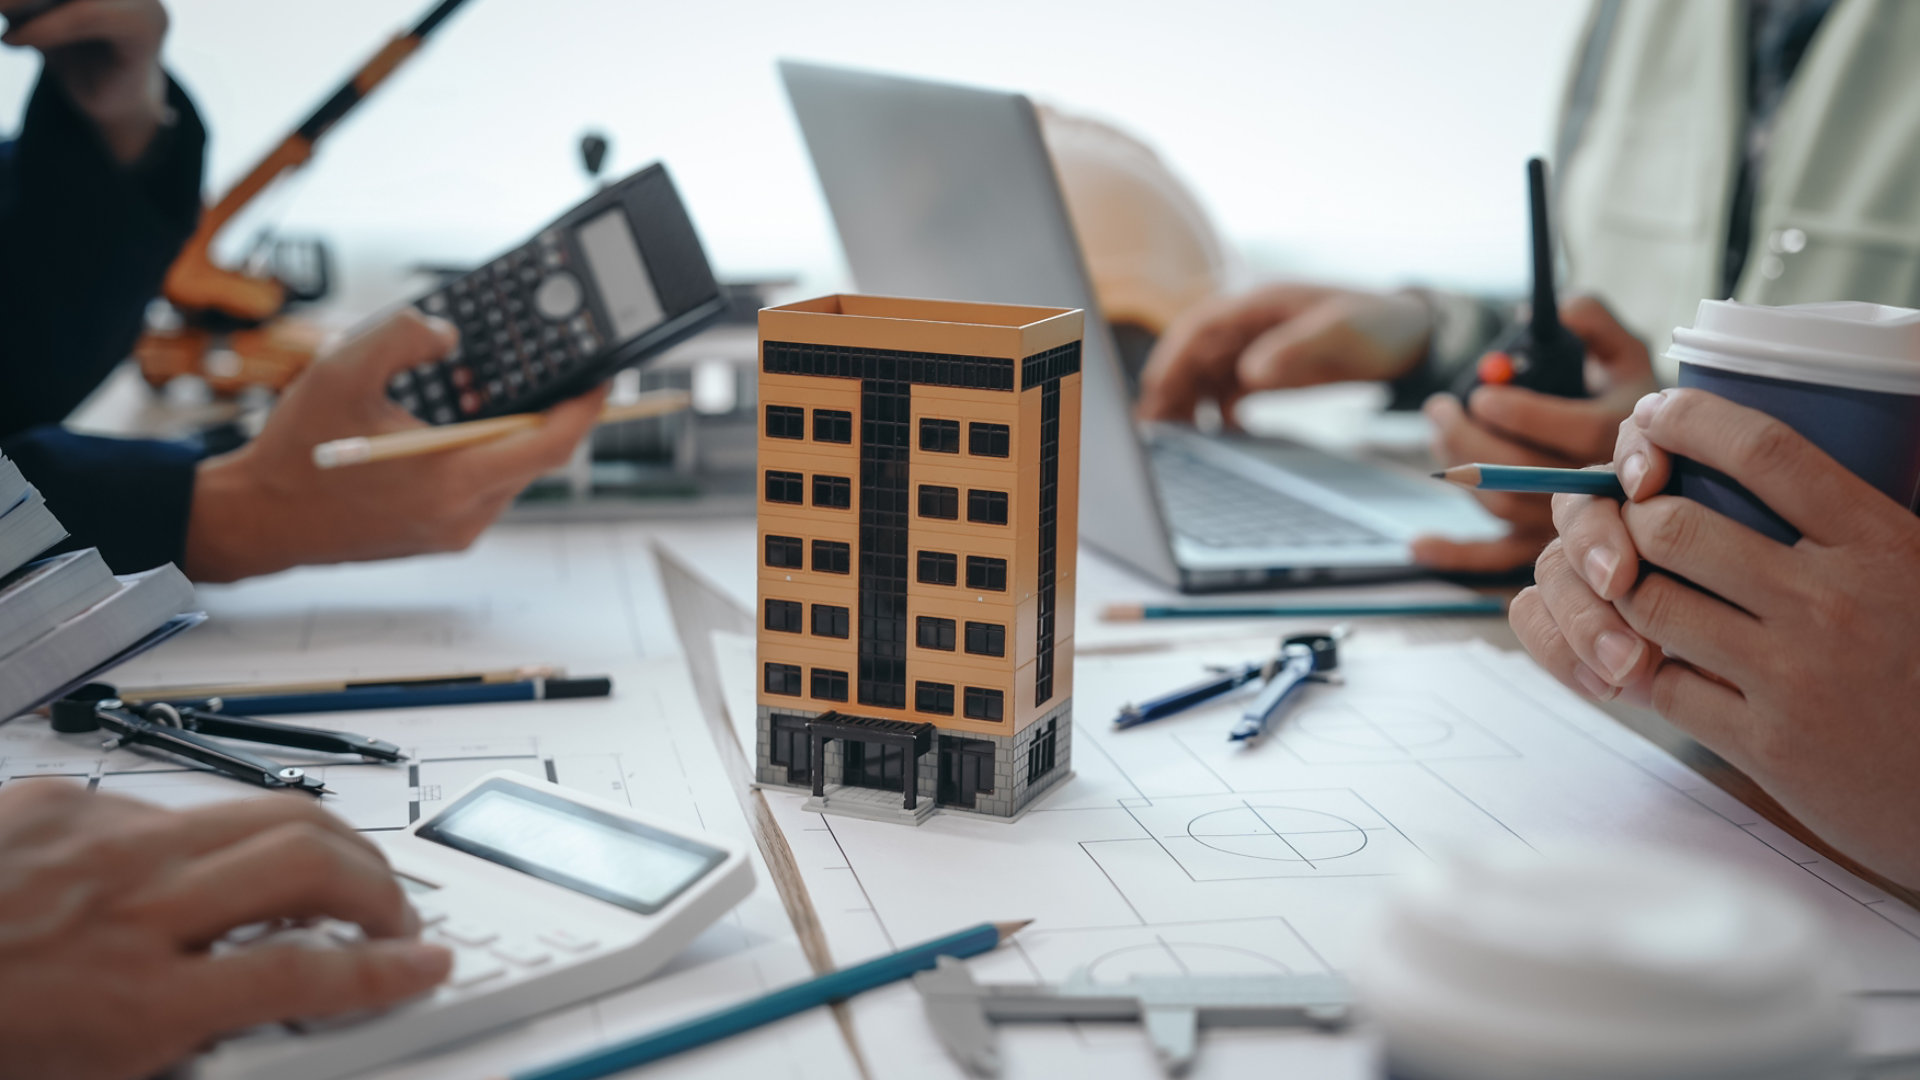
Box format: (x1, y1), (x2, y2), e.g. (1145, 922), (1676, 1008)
(0, 455), (205, 721)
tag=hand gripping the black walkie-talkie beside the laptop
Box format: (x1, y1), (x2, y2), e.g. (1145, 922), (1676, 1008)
(1413, 296), (1659, 573)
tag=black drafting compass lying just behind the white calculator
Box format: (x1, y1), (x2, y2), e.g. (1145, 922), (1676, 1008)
(50, 682), (407, 796)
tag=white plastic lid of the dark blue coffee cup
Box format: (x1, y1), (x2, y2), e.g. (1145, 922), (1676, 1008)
(1667, 300), (1920, 394)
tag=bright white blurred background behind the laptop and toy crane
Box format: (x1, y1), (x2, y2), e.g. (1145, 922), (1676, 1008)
(0, 0), (1586, 303)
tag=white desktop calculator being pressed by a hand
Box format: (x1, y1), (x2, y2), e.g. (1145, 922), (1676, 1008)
(186, 771), (753, 1080)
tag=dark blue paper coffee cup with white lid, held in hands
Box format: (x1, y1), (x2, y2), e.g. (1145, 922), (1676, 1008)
(1667, 300), (1920, 544)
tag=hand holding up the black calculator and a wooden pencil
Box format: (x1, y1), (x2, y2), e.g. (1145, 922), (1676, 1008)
(184, 309), (607, 580)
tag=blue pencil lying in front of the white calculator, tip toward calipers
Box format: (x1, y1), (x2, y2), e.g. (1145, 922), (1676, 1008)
(505, 922), (1027, 1080)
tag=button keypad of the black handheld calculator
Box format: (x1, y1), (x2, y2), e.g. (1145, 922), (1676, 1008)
(388, 229), (605, 425)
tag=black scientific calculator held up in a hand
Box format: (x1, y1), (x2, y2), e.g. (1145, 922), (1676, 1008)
(388, 165), (726, 425)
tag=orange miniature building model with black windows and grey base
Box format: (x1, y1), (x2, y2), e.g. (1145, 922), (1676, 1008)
(756, 296), (1083, 824)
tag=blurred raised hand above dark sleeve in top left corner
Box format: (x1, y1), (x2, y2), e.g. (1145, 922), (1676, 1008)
(0, 0), (167, 165)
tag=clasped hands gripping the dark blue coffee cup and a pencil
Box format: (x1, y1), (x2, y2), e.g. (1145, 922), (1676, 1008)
(1511, 390), (1920, 886)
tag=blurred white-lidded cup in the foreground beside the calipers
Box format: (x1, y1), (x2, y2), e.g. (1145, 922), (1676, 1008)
(1354, 846), (1853, 1080)
